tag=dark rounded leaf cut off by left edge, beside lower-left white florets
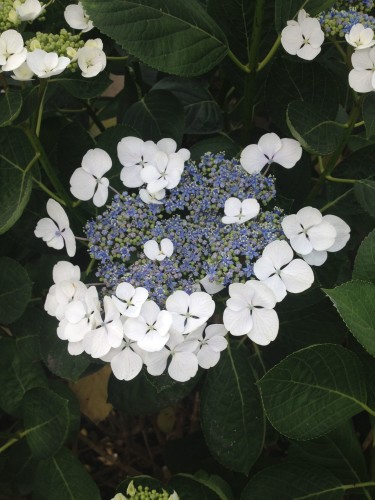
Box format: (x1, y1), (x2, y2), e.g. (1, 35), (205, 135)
(0, 257), (32, 325)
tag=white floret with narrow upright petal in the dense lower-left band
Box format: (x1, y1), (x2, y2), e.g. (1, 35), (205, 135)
(83, 296), (123, 358)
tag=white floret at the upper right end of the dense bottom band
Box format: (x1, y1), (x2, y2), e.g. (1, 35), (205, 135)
(165, 290), (215, 335)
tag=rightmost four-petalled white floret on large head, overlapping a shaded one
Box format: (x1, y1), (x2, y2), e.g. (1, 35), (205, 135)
(281, 207), (337, 256)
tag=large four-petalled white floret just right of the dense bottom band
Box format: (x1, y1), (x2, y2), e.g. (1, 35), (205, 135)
(223, 280), (279, 345)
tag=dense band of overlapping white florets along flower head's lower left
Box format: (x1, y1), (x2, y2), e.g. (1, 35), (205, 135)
(44, 261), (227, 382)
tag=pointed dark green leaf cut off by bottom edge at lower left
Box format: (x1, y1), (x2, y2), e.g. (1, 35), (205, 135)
(34, 448), (101, 500)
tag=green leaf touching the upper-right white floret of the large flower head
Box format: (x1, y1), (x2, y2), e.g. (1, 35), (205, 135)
(286, 101), (344, 156)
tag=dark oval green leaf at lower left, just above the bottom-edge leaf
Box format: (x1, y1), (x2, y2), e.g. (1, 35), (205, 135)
(23, 388), (70, 458)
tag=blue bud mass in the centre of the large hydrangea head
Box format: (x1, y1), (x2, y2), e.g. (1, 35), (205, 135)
(85, 153), (283, 307)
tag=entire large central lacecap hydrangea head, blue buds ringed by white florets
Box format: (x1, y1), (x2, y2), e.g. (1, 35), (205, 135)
(35, 133), (350, 382)
